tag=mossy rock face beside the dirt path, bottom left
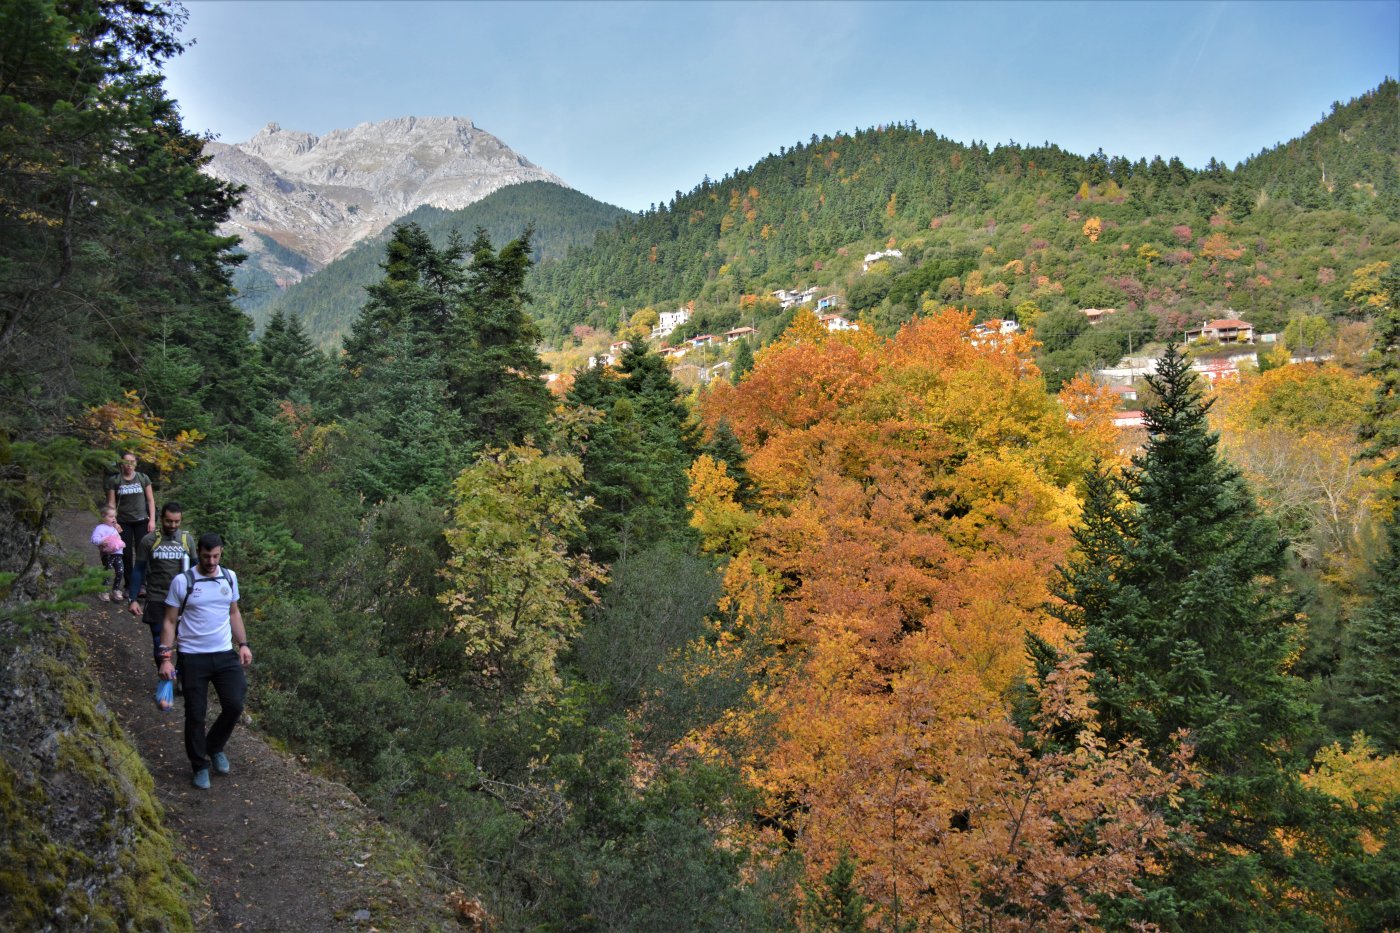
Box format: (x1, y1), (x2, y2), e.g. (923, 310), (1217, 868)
(0, 619), (193, 930)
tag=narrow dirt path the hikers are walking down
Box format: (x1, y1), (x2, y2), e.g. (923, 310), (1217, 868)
(56, 511), (469, 933)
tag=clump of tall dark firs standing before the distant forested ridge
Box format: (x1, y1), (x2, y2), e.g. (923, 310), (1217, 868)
(342, 223), (550, 499)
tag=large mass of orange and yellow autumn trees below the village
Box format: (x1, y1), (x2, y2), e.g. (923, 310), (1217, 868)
(692, 311), (1184, 929)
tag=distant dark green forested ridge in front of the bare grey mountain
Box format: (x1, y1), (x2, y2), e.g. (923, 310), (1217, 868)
(247, 182), (626, 347)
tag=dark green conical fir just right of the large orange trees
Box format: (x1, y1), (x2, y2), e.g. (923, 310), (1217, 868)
(1058, 346), (1315, 930)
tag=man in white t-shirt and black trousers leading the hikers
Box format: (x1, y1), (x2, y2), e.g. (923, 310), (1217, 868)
(155, 532), (253, 790)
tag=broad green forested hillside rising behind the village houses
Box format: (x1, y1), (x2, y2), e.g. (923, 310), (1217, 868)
(531, 80), (1400, 382)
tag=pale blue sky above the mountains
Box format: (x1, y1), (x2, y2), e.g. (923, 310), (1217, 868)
(167, 0), (1400, 210)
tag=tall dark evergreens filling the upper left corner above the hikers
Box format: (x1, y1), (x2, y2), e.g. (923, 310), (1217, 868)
(0, 0), (245, 431)
